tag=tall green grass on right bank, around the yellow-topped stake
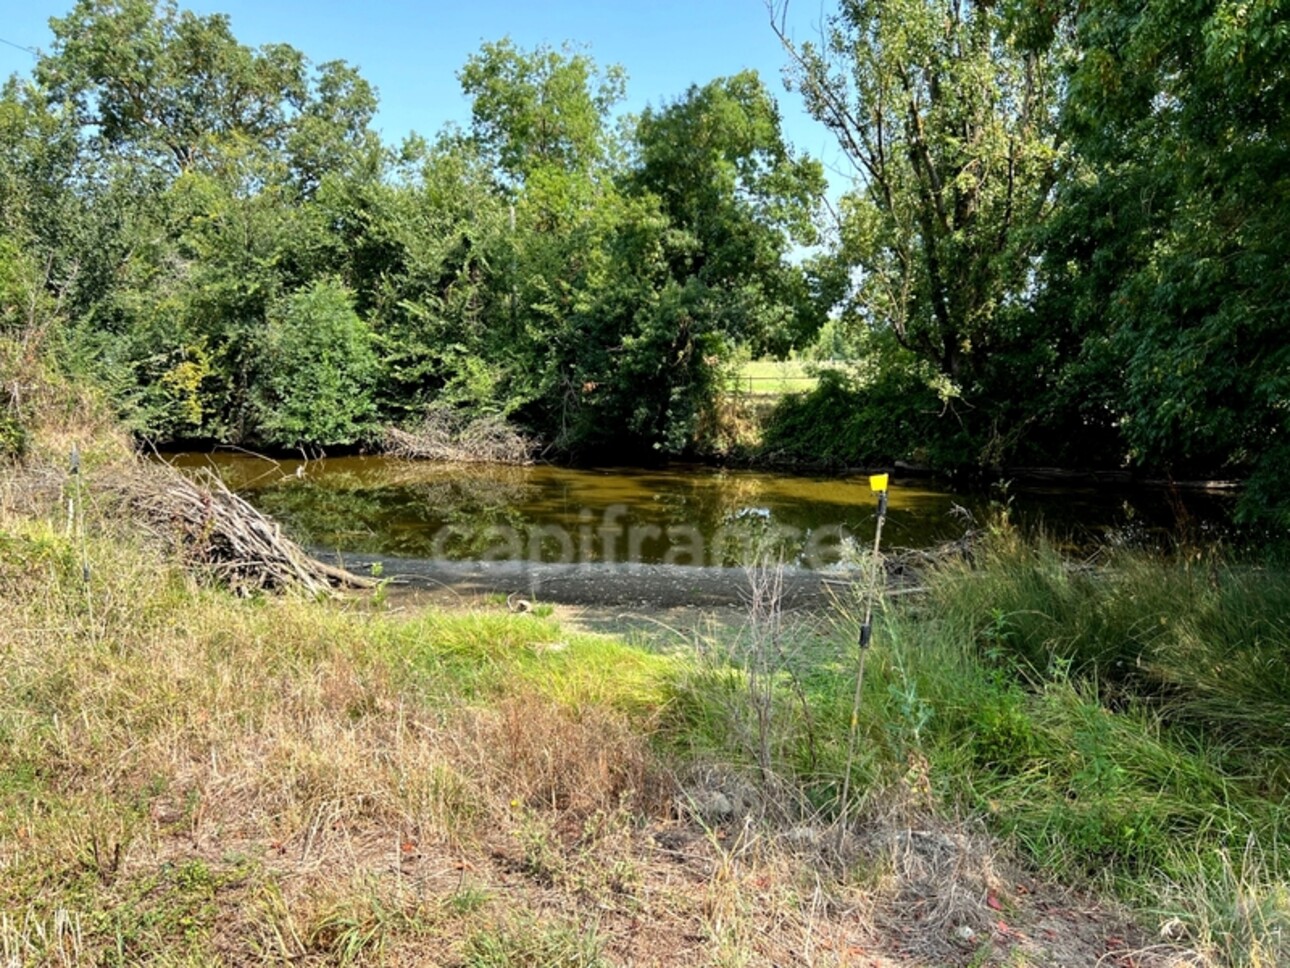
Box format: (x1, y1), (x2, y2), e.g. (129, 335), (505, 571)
(672, 529), (1290, 965)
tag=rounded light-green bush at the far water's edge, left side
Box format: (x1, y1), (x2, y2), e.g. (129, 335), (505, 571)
(248, 280), (377, 447)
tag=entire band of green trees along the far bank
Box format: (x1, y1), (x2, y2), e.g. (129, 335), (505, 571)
(0, 0), (1290, 500)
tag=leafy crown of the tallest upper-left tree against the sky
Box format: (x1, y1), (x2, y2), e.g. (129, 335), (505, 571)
(35, 0), (377, 188)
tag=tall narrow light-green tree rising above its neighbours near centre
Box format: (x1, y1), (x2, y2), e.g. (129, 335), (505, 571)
(459, 40), (623, 438)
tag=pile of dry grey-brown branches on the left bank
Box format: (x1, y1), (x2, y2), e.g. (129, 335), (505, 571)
(108, 465), (373, 595)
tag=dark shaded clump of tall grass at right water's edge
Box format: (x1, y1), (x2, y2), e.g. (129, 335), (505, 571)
(930, 541), (1290, 764)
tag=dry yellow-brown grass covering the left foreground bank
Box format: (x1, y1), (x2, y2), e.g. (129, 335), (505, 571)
(0, 508), (670, 964)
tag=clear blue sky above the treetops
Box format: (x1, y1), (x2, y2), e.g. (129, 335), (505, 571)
(0, 0), (849, 194)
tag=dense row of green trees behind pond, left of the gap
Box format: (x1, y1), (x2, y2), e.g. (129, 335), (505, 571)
(0, 6), (827, 459)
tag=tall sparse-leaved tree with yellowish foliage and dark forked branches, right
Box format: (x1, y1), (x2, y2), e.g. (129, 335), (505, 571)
(768, 0), (1062, 398)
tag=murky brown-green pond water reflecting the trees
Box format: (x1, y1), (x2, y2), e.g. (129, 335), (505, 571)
(163, 453), (1227, 568)
